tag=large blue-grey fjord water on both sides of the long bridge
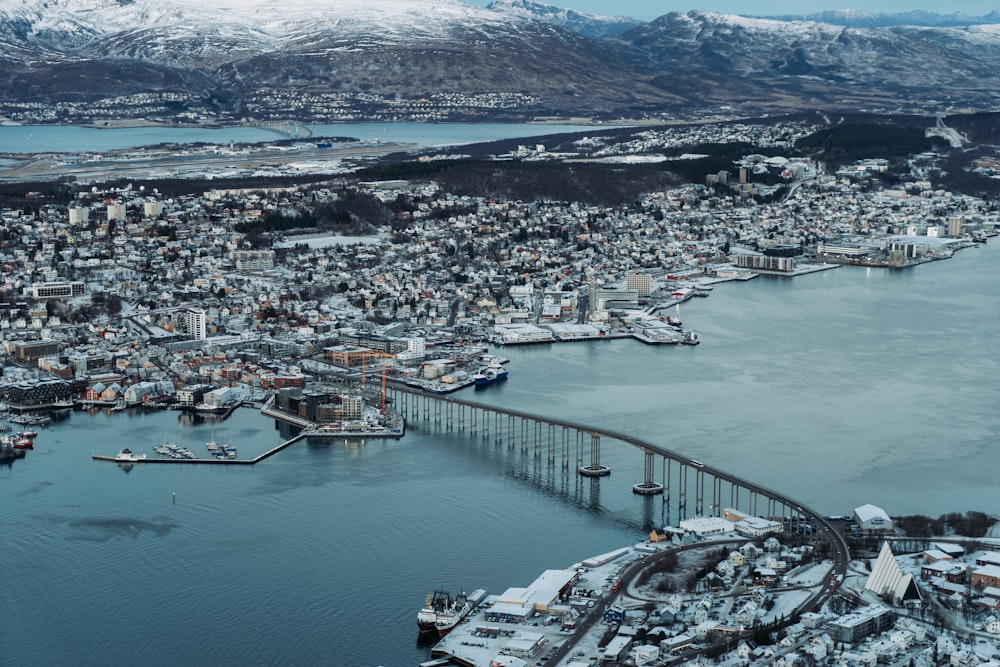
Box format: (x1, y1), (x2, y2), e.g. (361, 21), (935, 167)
(0, 242), (1000, 666)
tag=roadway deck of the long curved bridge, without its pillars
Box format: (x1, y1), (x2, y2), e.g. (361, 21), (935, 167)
(388, 385), (850, 580)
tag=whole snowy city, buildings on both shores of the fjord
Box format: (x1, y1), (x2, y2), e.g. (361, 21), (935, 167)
(0, 113), (1000, 667)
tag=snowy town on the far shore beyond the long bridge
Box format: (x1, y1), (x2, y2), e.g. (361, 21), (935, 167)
(0, 121), (998, 440)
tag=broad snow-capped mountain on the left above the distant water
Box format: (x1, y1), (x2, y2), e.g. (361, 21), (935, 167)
(0, 0), (671, 113)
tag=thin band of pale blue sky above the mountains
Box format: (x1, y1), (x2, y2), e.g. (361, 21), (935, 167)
(466, 0), (1000, 21)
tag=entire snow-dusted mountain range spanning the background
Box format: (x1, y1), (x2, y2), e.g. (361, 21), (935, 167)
(0, 0), (1000, 118)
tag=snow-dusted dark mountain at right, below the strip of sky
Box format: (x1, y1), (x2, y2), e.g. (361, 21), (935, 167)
(619, 11), (1000, 92)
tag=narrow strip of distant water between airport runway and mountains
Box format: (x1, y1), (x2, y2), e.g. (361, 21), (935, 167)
(0, 123), (596, 155)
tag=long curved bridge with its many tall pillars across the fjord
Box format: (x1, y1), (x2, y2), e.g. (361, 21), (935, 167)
(385, 385), (850, 574)
